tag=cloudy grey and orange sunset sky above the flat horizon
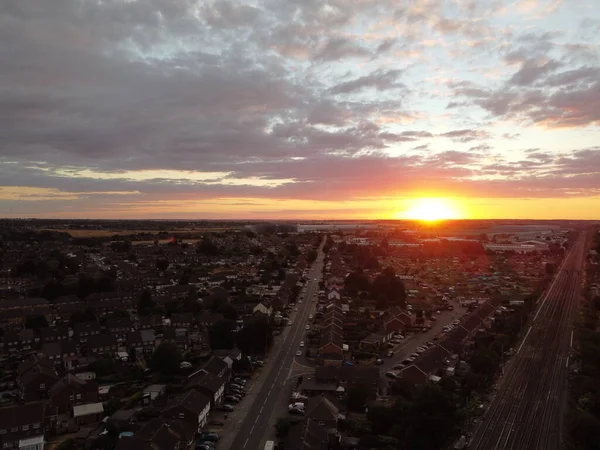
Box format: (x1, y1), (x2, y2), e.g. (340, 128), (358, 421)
(0, 0), (600, 220)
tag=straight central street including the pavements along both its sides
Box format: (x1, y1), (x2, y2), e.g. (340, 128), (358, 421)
(224, 239), (325, 450)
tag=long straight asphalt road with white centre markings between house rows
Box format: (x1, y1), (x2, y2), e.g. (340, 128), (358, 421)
(229, 239), (325, 450)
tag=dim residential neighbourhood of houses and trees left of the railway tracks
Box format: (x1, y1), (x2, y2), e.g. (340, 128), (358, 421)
(0, 224), (570, 450)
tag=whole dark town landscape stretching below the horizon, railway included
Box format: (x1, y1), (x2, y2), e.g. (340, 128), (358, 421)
(0, 219), (600, 450)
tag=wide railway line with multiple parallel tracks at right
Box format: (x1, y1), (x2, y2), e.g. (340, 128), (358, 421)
(469, 233), (585, 450)
